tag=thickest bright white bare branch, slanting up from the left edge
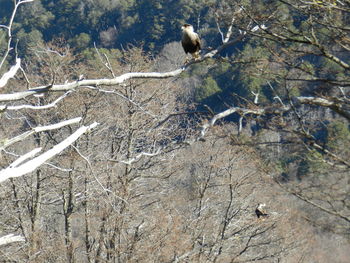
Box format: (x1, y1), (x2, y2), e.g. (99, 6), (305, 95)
(0, 122), (98, 182)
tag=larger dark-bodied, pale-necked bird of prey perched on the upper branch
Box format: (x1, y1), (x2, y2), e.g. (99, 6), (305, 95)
(181, 24), (201, 60)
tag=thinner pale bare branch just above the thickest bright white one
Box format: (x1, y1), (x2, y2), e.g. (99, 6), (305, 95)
(0, 117), (81, 151)
